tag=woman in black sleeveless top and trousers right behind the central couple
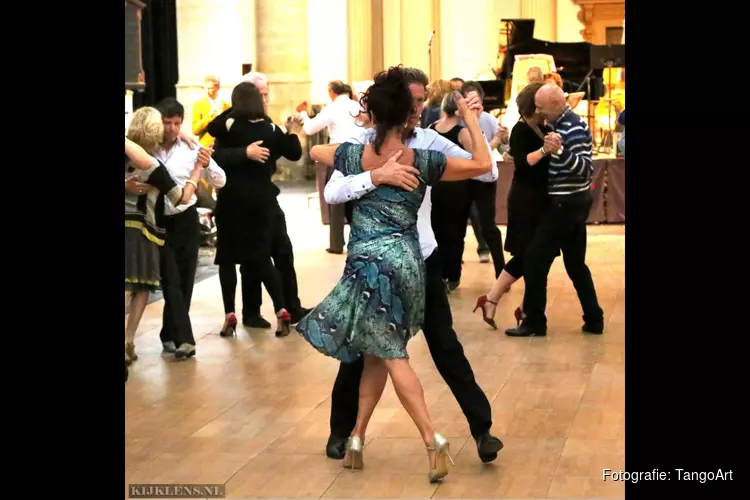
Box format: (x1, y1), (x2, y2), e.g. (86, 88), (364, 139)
(427, 92), (472, 291)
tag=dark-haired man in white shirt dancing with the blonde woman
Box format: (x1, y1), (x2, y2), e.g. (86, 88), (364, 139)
(129, 97), (227, 358)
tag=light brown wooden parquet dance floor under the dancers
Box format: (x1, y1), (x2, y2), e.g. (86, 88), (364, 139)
(125, 222), (625, 498)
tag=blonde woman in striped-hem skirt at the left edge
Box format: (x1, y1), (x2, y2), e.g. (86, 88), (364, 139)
(125, 107), (208, 364)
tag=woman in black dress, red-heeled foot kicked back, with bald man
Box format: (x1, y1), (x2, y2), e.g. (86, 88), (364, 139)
(474, 83), (552, 329)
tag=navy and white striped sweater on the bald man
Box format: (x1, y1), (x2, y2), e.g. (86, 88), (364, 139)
(548, 108), (594, 196)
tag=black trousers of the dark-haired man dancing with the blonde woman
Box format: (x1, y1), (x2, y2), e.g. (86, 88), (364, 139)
(159, 206), (200, 347)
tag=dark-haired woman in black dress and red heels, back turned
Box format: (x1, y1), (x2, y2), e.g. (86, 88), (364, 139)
(206, 82), (300, 336)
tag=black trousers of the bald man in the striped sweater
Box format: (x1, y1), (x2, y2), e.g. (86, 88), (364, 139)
(523, 191), (604, 327)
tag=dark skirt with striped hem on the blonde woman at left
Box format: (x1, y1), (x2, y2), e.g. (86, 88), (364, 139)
(125, 227), (161, 292)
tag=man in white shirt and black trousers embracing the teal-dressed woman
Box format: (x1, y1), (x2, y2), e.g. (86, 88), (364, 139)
(324, 68), (503, 462)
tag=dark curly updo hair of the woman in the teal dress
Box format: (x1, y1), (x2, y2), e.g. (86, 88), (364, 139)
(359, 65), (414, 154)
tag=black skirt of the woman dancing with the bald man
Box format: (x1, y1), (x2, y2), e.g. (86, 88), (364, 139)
(505, 181), (549, 255)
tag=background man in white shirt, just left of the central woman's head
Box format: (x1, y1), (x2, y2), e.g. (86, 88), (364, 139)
(297, 80), (359, 254)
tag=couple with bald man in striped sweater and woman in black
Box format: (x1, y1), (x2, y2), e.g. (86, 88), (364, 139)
(475, 83), (604, 337)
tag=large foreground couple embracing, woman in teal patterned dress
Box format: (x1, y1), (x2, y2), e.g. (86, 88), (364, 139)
(297, 66), (502, 482)
